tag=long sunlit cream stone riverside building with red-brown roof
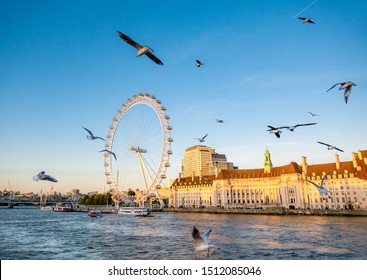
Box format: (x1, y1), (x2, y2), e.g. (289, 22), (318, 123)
(167, 146), (367, 209)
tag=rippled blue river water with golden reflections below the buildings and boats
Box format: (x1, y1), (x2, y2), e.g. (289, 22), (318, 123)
(0, 207), (367, 260)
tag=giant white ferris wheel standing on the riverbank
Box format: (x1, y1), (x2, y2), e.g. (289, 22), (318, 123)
(104, 93), (173, 205)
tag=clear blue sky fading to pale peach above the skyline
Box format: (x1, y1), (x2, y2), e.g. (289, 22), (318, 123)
(0, 0), (367, 195)
